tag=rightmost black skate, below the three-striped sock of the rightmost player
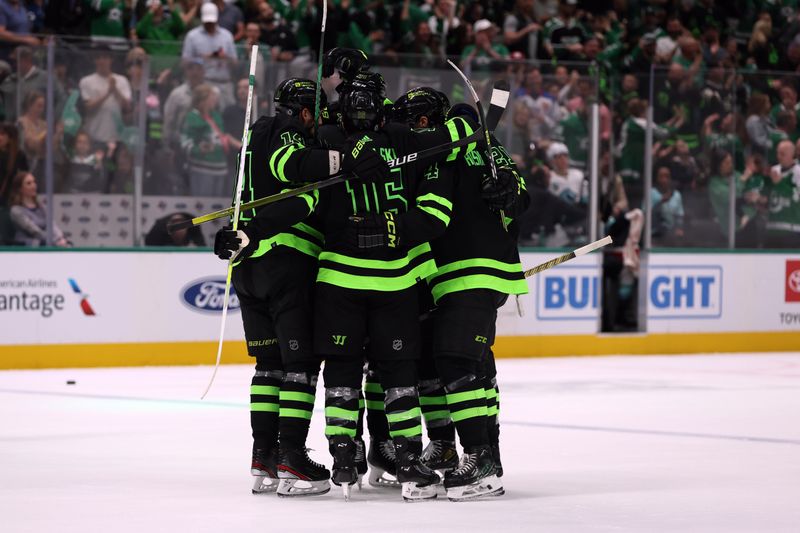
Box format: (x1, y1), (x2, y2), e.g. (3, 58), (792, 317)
(444, 445), (505, 502)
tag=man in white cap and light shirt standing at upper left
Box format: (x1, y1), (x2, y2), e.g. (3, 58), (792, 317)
(181, 2), (236, 107)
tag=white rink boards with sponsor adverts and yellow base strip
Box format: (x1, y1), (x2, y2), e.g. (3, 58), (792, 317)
(0, 251), (800, 368)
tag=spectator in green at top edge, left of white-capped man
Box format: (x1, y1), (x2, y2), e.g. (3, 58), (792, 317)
(136, 0), (189, 70)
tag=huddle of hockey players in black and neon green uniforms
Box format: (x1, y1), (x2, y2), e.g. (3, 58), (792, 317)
(214, 49), (528, 501)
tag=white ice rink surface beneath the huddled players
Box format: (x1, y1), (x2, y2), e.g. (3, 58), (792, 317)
(0, 354), (800, 533)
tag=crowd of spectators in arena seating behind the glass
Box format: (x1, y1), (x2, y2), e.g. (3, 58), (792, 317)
(0, 0), (800, 248)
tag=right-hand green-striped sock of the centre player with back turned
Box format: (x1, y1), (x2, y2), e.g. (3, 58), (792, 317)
(378, 361), (422, 447)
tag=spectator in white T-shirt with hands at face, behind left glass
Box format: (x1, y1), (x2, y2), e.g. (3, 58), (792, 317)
(78, 48), (132, 149)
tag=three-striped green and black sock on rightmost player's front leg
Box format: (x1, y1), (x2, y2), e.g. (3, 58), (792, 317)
(436, 356), (489, 448)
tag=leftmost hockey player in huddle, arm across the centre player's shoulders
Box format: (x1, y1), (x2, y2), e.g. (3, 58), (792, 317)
(214, 78), (388, 496)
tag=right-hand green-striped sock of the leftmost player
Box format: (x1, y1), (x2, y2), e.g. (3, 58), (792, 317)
(278, 372), (317, 450)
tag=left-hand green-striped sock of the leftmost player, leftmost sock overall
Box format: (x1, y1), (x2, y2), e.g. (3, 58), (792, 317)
(255, 362), (283, 450)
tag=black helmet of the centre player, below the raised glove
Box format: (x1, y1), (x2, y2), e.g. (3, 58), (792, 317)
(336, 72), (386, 133)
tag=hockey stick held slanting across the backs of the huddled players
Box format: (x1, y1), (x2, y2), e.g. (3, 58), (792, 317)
(167, 129), (482, 234)
